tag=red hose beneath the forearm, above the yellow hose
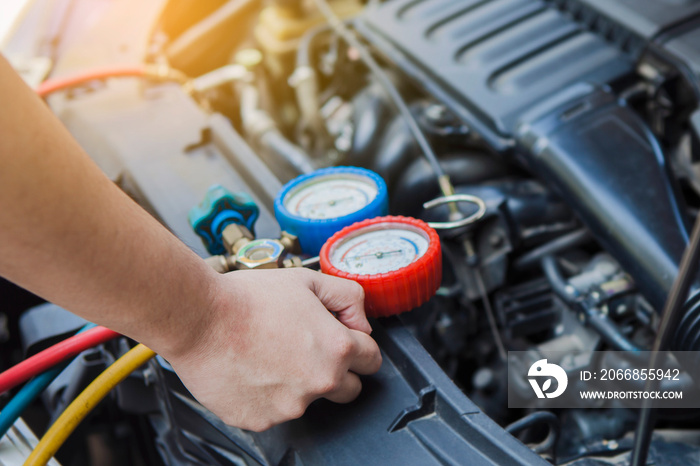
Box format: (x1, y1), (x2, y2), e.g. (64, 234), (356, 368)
(0, 327), (119, 394)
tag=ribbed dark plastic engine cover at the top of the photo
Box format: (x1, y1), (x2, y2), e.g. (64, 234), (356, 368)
(357, 0), (633, 150)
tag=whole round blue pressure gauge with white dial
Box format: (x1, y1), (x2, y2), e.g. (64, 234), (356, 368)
(275, 167), (389, 256)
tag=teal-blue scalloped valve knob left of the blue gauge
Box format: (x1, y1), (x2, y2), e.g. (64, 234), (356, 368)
(188, 185), (260, 255)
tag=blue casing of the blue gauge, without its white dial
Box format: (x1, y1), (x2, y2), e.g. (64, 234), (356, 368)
(275, 167), (389, 256)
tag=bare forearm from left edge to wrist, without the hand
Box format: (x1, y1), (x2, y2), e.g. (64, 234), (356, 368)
(0, 54), (217, 353)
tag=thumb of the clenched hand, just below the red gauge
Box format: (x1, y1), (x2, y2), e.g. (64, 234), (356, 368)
(312, 273), (372, 335)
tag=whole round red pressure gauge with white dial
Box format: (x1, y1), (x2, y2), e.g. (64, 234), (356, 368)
(321, 216), (442, 317)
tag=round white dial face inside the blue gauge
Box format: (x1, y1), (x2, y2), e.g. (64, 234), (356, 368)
(283, 174), (379, 220)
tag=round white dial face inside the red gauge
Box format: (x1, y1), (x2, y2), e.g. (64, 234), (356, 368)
(329, 222), (429, 275)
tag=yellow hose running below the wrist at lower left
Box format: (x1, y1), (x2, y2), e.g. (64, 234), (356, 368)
(24, 345), (156, 466)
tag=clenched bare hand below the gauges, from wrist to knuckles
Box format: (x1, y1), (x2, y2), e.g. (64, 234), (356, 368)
(163, 269), (382, 432)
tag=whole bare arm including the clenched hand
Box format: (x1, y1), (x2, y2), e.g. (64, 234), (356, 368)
(0, 57), (381, 430)
